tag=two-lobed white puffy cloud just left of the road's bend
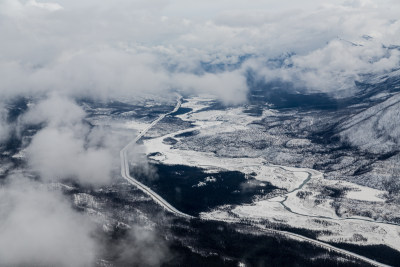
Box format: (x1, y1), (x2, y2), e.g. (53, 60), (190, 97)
(22, 95), (114, 186)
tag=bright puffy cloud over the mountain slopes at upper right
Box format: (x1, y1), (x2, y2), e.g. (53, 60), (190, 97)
(246, 38), (400, 97)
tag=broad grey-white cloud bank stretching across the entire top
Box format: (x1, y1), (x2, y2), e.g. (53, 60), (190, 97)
(0, 0), (400, 104)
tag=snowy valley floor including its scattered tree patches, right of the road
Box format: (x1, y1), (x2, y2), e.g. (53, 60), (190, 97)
(122, 94), (400, 258)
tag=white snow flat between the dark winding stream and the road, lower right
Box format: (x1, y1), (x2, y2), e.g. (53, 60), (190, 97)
(201, 198), (400, 253)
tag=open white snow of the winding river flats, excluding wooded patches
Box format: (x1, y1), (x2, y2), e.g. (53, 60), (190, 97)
(126, 97), (400, 251)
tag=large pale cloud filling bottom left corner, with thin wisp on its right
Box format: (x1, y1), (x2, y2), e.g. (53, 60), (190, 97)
(0, 175), (170, 267)
